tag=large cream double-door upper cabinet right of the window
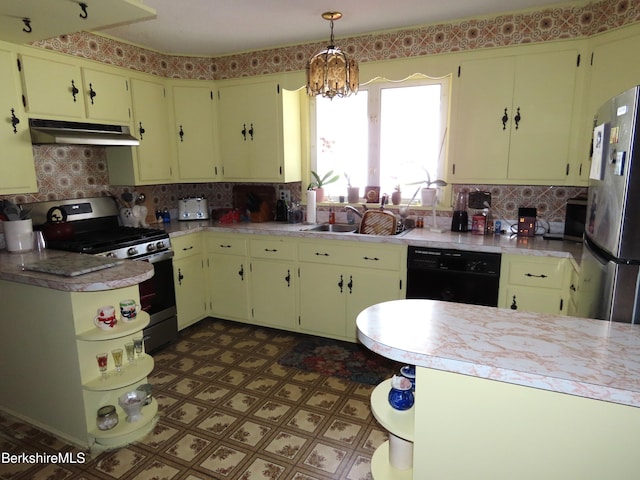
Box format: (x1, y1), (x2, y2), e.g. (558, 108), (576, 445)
(449, 48), (579, 184)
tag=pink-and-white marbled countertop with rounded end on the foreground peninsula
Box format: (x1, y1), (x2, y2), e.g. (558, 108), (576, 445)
(357, 300), (640, 407)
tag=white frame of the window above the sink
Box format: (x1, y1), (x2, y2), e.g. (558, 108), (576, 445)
(310, 74), (450, 203)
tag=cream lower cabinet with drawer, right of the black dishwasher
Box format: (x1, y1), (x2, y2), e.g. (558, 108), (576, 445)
(498, 255), (571, 315)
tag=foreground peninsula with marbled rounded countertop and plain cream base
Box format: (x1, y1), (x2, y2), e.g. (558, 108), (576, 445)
(357, 300), (640, 480)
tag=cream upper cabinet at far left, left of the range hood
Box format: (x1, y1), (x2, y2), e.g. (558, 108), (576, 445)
(0, 47), (38, 194)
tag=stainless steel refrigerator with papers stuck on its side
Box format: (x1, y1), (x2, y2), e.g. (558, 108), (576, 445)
(577, 86), (640, 323)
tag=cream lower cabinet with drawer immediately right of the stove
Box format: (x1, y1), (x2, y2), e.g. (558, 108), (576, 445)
(171, 233), (207, 330)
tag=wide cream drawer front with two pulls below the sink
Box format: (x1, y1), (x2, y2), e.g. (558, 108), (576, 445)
(299, 242), (401, 270)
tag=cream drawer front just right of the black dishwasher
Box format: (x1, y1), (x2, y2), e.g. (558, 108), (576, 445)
(505, 257), (567, 288)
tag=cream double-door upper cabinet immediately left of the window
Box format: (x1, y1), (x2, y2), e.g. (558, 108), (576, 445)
(218, 80), (302, 182)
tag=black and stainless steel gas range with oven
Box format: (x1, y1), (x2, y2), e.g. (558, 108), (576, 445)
(22, 197), (178, 352)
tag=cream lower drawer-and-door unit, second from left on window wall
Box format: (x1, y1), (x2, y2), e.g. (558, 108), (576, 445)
(249, 237), (298, 330)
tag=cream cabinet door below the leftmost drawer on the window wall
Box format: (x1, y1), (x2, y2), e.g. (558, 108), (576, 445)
(208, 254), (249, 321)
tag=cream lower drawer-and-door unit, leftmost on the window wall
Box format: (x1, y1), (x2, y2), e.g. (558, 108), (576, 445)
(206, 233), (249, 322)
